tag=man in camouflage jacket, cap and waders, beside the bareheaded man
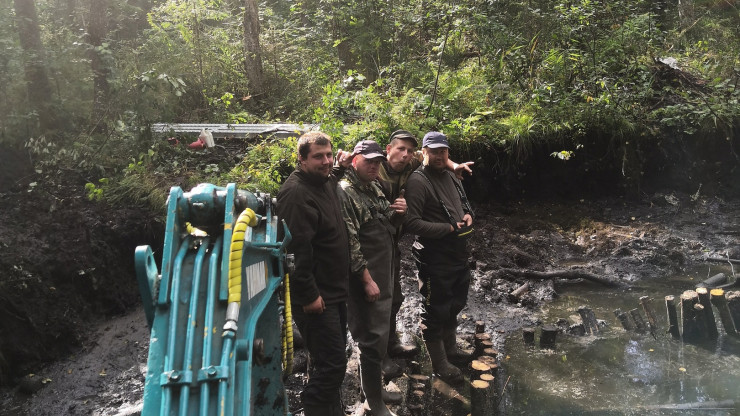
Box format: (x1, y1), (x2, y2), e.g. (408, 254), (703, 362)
(340, 140), (406, 416)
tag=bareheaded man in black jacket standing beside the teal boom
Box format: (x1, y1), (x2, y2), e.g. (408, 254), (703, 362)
(277, 132), (352, 416)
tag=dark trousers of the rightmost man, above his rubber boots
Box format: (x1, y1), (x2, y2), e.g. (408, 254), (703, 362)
(416, 262), (470, 341)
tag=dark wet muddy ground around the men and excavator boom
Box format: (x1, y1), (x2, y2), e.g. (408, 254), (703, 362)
(0, 145), (740, 416)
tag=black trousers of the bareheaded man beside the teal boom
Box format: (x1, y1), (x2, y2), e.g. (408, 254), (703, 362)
(293, 302), (347, 406)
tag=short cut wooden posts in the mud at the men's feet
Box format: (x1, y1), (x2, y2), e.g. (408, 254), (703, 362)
(406, 321), (499, 416)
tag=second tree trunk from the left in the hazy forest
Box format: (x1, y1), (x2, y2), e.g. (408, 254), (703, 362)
(87, 0), (110, 131)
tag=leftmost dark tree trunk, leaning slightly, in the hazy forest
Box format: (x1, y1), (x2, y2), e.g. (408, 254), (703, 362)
(13, 0), (56, 132)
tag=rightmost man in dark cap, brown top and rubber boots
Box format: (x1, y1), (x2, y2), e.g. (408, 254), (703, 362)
(404, 131), (473, 383)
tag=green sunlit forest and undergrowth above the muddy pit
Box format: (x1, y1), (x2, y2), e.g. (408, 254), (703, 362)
(0, 0), (740, 203)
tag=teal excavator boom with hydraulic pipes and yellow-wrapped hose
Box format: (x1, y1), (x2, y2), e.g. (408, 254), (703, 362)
(135, 184), (292, 416)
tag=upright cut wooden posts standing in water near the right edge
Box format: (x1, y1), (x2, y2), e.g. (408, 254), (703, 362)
(614, 287), (740, 342)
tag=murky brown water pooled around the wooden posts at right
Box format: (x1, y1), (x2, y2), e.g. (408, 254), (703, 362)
(501, 266), (740, 415)
